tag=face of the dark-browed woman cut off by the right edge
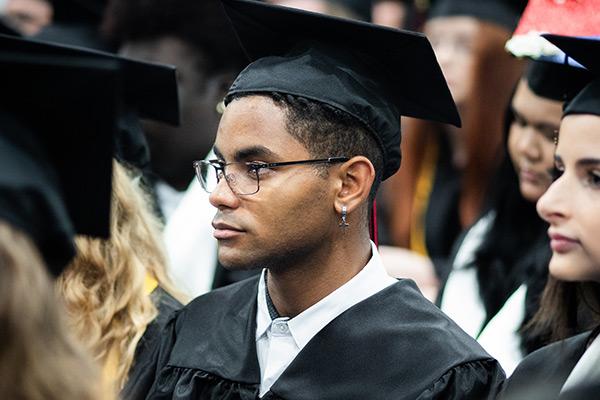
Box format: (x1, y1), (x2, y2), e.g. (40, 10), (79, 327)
(537, 115), (600, 282)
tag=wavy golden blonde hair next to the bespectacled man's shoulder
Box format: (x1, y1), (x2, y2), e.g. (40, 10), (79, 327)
(58, 161), (183, 388)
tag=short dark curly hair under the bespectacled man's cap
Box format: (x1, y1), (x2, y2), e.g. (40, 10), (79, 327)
(226, 92), (383, 203)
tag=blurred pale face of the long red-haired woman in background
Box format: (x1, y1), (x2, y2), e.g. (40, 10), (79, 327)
(424, 17), (480, 106)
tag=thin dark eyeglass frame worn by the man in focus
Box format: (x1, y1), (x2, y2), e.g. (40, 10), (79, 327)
(192, 157), (350, 196)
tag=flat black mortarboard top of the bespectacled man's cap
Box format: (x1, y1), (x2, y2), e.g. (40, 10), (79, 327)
(222, 0), (460, 126)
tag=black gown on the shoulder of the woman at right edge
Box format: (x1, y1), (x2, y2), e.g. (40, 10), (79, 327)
(499, 332), (590, 400)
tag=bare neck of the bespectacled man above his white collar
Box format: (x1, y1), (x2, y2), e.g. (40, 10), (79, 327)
(267, 234), (371, 318)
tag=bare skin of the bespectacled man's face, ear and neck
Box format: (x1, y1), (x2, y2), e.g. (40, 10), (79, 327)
(210, 96), (375, 317)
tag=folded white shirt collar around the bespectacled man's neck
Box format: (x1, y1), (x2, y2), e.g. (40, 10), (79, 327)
(256, 242), (397, 349)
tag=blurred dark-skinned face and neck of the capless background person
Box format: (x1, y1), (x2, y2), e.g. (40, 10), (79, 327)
(120, 36), (234, 191)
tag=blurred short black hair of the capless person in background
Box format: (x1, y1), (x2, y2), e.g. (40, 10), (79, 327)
(101, 0), (248, 73)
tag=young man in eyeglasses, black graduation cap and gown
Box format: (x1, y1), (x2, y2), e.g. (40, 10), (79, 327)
(130, 0), (504, 400)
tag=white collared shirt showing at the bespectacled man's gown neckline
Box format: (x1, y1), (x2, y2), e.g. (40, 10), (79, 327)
(256, 242), (397, 397)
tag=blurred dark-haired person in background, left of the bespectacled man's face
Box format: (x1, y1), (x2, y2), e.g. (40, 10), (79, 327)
(102, 0), (246, 221)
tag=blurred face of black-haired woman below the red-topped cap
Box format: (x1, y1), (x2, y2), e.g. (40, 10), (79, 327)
(508, 80), (562, 202)
